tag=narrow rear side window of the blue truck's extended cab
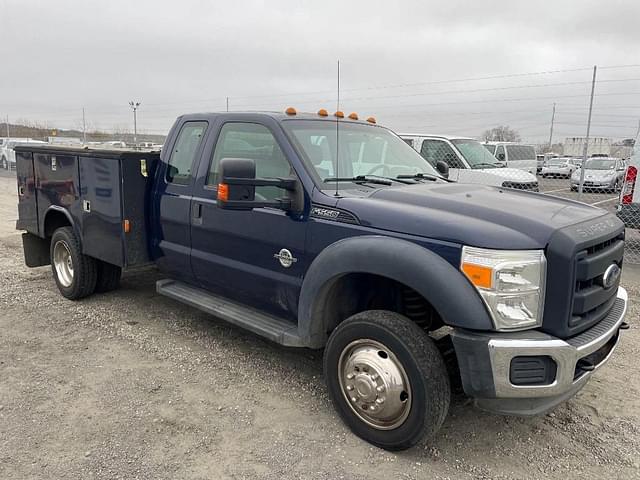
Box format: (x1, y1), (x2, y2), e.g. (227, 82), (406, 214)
(166, 122), (207, 185)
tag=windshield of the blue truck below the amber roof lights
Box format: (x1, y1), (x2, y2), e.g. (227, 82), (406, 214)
(283, 120), (440, 188)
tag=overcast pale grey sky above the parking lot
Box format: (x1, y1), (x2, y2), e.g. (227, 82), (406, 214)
(0, 0), (640, 141)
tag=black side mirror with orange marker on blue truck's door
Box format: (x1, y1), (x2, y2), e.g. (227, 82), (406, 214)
(217, 158), (304, 213)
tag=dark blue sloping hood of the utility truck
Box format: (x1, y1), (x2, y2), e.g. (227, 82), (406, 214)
(337, 183), (615, 250)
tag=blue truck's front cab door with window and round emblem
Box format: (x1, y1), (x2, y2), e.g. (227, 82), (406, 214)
(191, 122), (307, 319)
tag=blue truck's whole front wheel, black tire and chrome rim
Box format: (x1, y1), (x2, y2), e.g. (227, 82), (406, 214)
(324, 310), (451, 450)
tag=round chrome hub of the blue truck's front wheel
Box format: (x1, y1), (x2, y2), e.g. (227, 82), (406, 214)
(338, 339), (411, 430)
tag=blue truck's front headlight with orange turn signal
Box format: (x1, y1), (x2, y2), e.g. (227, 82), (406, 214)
(460, 247), (547, 330)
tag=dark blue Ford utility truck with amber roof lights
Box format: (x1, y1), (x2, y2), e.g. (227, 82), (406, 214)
(16, 109), (627, 449)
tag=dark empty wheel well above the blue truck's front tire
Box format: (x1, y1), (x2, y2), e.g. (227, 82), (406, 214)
(313, 273), (443, 342)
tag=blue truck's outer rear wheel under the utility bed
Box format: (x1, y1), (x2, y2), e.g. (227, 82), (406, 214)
(49, 227), (97, 300)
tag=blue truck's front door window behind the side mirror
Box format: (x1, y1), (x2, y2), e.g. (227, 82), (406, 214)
(207, 123), (292, 200)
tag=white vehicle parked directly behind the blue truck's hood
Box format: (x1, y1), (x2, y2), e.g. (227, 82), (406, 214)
(400, 134), (539, 191)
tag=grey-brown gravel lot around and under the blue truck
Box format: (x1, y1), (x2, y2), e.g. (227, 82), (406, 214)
(0, 175), (640, 480)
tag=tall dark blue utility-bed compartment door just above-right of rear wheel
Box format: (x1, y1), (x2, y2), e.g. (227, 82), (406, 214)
(78, 156), (124, 266)
